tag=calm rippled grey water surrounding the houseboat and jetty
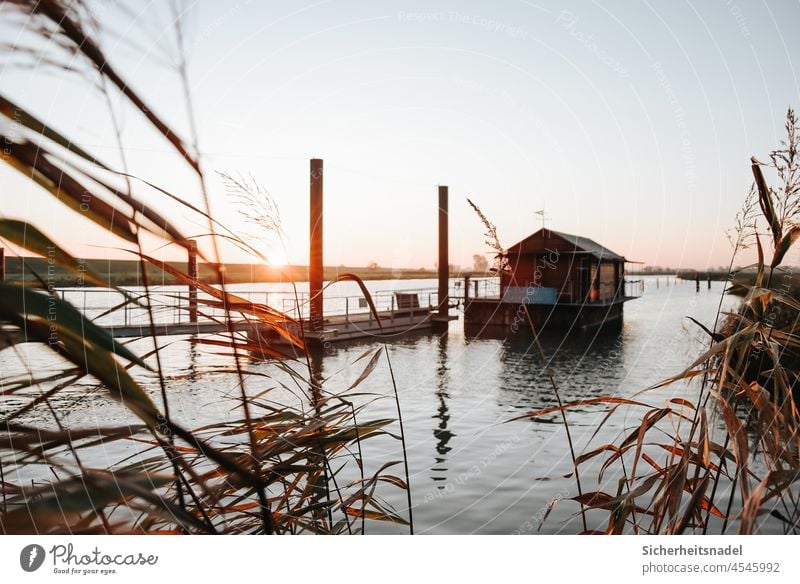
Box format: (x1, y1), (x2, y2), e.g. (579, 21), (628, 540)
(0, 277), (738, 533)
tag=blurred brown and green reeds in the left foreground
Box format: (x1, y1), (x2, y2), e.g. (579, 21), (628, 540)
(0, 0), (410, 534)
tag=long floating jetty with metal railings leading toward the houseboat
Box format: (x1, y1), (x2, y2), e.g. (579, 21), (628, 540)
(21, 283), (478, 346)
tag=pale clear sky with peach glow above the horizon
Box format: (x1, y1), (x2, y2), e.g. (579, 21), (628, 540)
(0, 0), (800, 268)
